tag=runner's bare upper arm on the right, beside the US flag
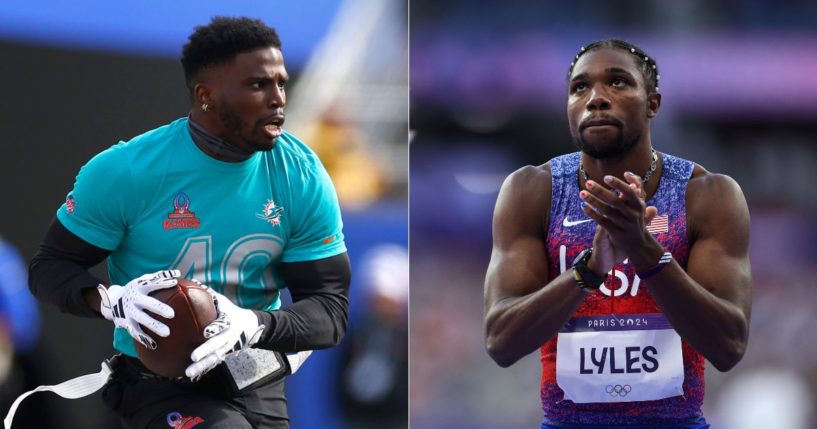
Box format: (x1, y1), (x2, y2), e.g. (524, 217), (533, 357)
(687, 175), (752, 317)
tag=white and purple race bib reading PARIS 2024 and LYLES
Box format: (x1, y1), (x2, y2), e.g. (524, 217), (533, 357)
(556, 314), (684, 403)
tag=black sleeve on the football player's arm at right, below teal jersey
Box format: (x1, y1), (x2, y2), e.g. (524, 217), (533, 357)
(255, 253), (351, 352)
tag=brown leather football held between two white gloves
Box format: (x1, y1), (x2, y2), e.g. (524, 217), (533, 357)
(136, 279), (216, 378)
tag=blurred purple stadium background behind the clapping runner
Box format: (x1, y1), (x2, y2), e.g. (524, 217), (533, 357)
(410, 0), (817, 429)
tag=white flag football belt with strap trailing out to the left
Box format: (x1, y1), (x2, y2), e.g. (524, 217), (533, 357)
(3, 348), (312, 429)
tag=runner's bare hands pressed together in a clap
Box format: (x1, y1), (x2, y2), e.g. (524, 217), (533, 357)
(579, 173), (657, 274)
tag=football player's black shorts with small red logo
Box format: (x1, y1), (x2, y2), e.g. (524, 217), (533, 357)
(102, 355), (289, 429)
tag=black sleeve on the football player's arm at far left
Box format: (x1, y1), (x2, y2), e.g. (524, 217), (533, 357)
(28, 218), (111, 317)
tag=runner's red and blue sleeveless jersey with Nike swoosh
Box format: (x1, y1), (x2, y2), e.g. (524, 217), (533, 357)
(540, 152), (704, 425)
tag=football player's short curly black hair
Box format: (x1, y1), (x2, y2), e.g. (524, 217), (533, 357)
(181, 16), (281, 94)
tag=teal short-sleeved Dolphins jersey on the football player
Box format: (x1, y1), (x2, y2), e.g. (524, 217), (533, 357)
(57, 118), (346, 356)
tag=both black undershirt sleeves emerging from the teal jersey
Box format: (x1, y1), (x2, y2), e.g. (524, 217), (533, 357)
(29, 218), (351, 352)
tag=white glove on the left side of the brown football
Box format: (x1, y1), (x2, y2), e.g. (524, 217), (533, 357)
(97, 270), (181, 350)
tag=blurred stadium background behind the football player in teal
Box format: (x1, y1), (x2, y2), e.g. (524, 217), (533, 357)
(0, 0), (408, 429)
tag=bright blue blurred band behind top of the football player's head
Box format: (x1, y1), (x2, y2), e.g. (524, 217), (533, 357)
(0, 0), (342, 68)
